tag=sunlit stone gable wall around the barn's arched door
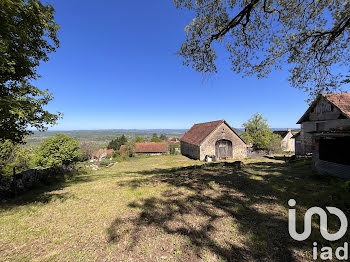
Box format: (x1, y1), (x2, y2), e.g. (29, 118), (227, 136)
(199, 123), (247, 160)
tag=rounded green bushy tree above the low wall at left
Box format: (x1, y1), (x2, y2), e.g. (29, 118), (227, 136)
(34, 134), (82, 168)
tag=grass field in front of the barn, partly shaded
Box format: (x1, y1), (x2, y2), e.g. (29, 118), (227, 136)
(0, 156), (350, 261)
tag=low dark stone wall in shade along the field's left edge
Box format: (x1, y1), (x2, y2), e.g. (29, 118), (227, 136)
(0, 166), (74, 199)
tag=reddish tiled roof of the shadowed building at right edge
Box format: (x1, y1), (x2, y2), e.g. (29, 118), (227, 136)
(297, 93), (350, 124)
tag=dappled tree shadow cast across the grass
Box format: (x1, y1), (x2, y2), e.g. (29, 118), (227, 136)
(107, 162), (350, 261)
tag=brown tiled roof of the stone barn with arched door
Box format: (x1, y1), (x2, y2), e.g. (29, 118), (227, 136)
(181, 120), (224, 146)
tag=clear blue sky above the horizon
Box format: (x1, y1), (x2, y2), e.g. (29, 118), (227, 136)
(36, 0), (348, 130)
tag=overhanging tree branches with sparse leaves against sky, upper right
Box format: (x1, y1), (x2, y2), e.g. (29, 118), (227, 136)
(174, 0), (350, 96)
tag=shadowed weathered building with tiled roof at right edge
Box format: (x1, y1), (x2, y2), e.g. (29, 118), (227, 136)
(295, 93), (350, 178)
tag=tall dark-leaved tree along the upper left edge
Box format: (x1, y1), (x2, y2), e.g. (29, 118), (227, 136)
(0, 0), (61, 143)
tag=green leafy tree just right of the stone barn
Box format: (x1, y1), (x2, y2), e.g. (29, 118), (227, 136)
(242, 113), (274, 150)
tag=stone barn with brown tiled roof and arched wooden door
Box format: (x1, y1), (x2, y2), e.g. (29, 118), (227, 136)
(180, 120), (247, 160)
